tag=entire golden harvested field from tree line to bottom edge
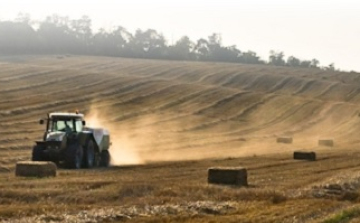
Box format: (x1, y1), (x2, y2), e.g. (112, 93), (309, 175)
(0, 55), (360, 222)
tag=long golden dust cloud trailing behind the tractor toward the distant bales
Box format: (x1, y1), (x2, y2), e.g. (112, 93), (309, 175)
(85, 103), (324, 166)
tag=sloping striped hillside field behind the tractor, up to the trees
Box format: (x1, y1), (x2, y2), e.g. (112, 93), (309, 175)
(0, 57), (360, 164)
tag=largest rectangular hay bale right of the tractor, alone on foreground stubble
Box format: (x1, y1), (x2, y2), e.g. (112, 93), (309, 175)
(208, 167), (248, 186)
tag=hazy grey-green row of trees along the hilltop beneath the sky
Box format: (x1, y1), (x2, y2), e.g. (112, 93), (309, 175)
(0, 14), (335, 70)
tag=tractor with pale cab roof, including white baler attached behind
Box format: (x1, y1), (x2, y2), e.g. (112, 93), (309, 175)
(32, 112), (110, 169)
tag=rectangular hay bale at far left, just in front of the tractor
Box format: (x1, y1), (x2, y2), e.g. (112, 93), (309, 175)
(15, 161), (57, 177)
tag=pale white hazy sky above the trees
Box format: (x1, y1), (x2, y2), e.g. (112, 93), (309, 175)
(0, 0), (360, 71)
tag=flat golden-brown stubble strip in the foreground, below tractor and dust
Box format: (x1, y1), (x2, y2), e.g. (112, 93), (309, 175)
(0, 152), (360, 222)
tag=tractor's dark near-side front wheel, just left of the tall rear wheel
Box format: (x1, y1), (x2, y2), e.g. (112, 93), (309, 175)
(65, 143), (84, 169)
